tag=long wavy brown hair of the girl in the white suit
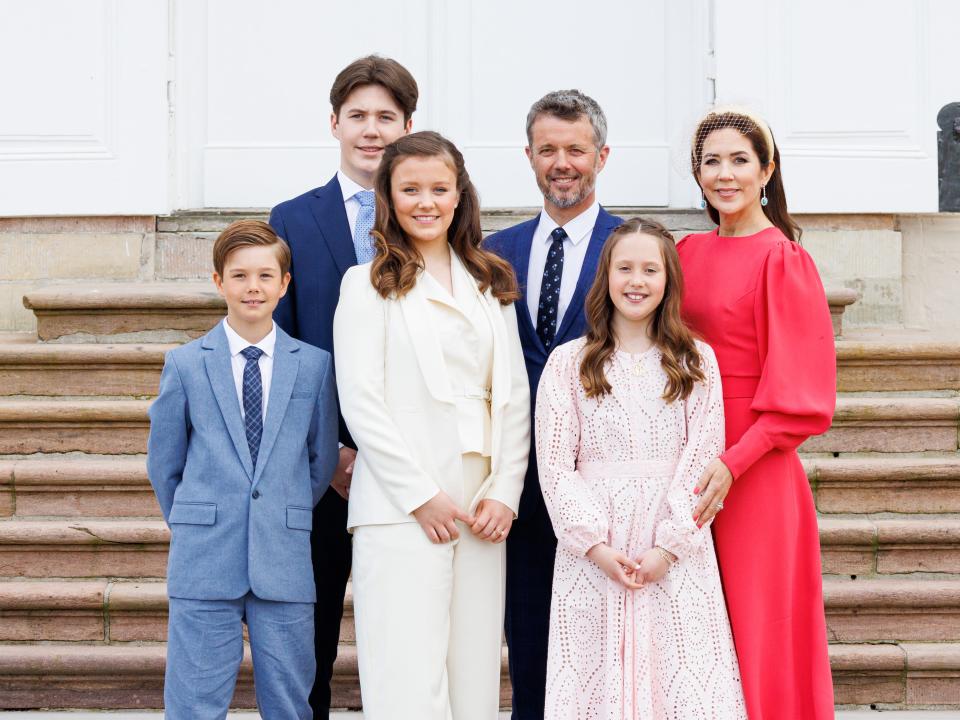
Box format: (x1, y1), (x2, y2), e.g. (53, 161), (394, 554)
(370, 131), (520, 305)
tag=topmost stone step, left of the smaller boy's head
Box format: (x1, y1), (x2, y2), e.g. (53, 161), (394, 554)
(23, 282), (226, 343)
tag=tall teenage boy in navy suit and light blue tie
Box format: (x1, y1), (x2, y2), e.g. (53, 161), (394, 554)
(270, 55), (418, 718)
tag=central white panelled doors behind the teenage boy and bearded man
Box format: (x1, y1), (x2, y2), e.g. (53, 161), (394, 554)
(179, 0), (706, 207)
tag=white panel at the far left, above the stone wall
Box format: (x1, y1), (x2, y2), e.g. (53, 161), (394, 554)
(0, 0), (170, 215)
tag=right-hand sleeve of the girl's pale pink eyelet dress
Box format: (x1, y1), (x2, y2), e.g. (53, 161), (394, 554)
(655, 343), (724, 560)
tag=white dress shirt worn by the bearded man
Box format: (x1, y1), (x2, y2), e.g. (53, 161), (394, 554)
(527, 201), (600, 329)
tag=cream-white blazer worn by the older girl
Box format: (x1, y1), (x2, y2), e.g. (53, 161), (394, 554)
(333, 253), (530, 528)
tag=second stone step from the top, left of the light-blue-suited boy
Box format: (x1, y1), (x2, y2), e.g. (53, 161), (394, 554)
(0, 342), (174, 397)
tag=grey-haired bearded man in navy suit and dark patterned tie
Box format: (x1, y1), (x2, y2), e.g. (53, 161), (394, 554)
(486, 90), (623, 720)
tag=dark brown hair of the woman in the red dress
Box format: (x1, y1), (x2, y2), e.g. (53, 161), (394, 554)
(690, 111), (803, 241)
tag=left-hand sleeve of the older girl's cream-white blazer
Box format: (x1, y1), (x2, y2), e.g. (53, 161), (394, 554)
(333, 265), (440, 513)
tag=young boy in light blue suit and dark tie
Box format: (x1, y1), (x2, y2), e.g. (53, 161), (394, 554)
(147, 220), (338, 720)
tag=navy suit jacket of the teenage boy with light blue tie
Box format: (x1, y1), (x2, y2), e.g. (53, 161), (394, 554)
(270, 175), (357, 448)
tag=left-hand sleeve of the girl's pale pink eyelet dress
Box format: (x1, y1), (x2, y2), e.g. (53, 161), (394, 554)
(535, 347), (609, 555)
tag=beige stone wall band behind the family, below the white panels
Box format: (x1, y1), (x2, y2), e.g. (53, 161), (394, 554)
(0, 208), (960, 334)
